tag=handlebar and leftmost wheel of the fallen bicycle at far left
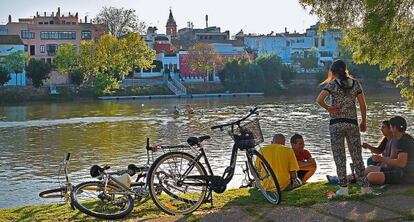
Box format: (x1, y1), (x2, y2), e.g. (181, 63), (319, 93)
(39, 153), (75, 210)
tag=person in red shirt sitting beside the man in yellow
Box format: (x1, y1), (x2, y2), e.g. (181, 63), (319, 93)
(290, 134), (316, 183)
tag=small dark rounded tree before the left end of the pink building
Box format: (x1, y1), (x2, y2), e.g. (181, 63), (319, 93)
(27, 59), (51, 88)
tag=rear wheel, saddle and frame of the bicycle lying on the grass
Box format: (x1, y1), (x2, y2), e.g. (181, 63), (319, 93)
(71, 138), (156, 220)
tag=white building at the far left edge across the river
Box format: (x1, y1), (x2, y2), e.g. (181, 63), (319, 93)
(0, 35), (26, 86)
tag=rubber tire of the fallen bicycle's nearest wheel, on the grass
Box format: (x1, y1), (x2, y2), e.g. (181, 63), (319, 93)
(71, 181), (134, 220)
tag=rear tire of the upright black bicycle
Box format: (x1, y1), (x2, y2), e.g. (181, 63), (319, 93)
(147, 152), (209, 215)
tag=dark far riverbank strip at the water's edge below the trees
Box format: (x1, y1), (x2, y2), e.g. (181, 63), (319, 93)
(0, 79), (399, 105)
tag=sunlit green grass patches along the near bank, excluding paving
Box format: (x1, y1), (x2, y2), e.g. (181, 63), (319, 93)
(0, 182), (414, 221)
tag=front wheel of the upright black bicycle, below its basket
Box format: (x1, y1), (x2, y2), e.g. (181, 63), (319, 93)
(246, 150), (282, 204)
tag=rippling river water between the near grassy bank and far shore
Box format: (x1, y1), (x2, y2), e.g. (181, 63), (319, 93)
(0, 95), (414, 208)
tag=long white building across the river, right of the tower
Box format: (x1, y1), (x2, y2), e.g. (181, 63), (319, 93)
(243, 24), (342, 65)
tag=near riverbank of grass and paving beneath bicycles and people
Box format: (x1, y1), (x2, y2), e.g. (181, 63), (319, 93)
(0, 182), (414, 222)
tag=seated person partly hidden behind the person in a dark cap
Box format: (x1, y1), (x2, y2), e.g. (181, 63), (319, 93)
(362, 120), (397, 175)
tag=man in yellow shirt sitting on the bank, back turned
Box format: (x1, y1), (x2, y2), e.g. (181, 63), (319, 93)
(260, 134), (301, 190)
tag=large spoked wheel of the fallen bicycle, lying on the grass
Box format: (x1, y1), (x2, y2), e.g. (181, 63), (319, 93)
(71, 181), (134, 220)
